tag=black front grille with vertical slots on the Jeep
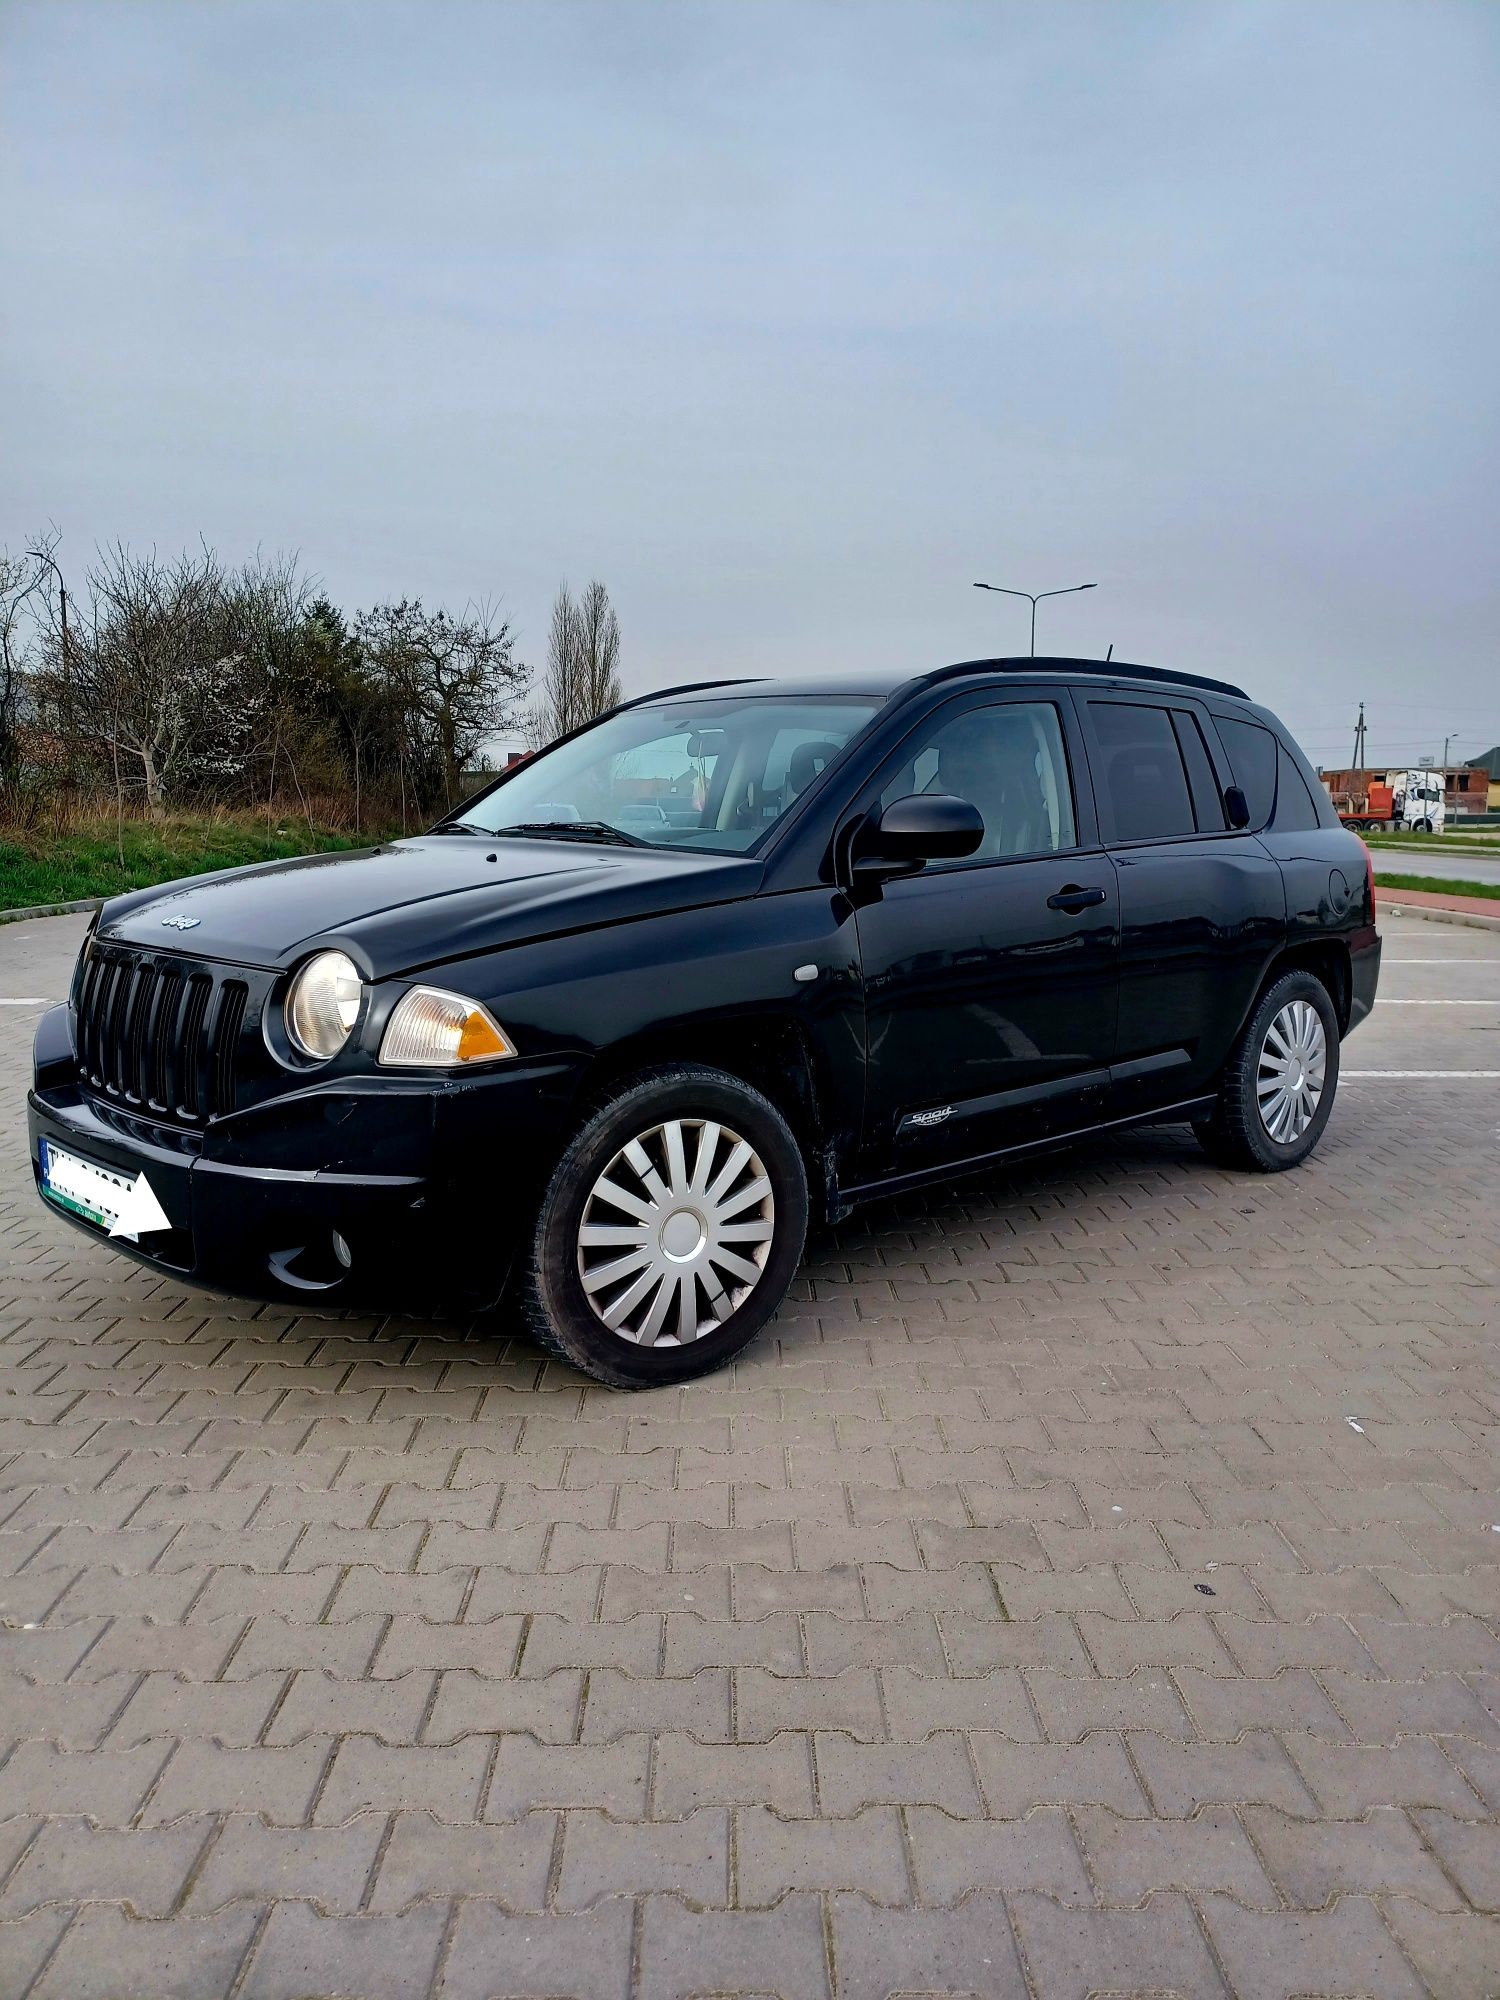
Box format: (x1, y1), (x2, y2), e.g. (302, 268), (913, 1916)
(76, 946), (250, 1124)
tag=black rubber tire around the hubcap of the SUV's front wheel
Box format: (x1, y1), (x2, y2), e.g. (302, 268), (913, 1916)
(518, 1064), (808, 1388)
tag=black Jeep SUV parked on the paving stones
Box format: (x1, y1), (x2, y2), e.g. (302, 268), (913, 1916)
(30, 660), (1380, 1386)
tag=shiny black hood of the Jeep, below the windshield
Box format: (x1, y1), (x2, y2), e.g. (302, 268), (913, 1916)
(100, 834), (760, 978)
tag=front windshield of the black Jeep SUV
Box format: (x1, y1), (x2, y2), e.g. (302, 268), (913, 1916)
(454, 696), (880, 854)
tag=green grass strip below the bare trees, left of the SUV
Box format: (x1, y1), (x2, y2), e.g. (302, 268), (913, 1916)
(0, 814), (368, 910)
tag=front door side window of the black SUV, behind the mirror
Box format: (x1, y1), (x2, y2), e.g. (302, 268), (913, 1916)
(880, 702), (1078, 860)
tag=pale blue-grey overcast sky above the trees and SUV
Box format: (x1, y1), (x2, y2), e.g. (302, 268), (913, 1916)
(0, 0), (1500, 764)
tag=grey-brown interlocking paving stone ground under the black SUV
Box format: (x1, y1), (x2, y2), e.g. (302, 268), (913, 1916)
(0, 920), (1500, 2000)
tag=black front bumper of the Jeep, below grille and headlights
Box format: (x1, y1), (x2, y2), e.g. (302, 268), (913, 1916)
(28, 1008), (572, 1314)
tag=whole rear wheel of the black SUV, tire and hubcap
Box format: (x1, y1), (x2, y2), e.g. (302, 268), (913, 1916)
(1194, 972), (1338, 1174)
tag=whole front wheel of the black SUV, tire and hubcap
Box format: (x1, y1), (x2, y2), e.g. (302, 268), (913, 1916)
(522, 1064), (808, 1388)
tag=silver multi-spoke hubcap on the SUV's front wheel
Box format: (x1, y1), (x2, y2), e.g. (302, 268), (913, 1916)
(578, 1118), (776, 1348)
